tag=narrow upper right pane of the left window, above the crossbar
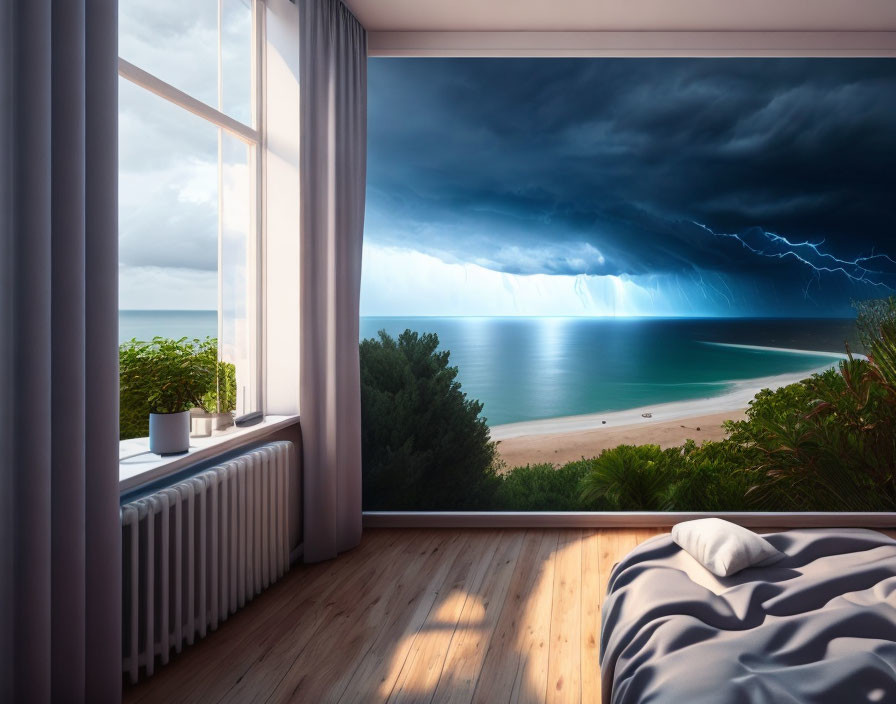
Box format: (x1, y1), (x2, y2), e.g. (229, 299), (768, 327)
(220, 0), (253, 125)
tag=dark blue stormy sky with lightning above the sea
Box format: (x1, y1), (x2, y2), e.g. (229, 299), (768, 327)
(361, 58), (896, 317)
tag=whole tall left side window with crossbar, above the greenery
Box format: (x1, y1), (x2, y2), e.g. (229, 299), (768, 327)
(119, 0), (262, 426)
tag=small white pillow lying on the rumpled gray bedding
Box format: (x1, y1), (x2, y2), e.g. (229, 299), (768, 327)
(672, 518), (784, 577)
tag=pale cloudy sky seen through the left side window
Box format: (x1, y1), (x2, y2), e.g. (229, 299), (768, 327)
(118, 0), (252, 310)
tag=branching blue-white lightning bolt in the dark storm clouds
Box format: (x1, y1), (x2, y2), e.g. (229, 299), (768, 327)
(691, 220), (896, 296)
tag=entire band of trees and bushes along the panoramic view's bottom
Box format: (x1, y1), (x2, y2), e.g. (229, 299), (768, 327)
(361, 298), (896, 512)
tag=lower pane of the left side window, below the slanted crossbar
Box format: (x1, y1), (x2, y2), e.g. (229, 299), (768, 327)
(119, 79), (258, 414)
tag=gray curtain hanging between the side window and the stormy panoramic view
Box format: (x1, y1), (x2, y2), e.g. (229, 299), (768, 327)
(299, 0), (367, 562)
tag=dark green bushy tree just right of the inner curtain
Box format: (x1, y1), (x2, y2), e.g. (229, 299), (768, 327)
(360, 330), (500, 510)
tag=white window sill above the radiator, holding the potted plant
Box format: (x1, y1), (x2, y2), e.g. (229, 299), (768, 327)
(118, 416), (299, 493)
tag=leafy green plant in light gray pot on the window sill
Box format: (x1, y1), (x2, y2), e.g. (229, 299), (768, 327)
(120, 337), (215, 455)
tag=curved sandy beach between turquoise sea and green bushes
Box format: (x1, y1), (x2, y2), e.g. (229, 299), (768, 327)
(491, 355), (839, 467)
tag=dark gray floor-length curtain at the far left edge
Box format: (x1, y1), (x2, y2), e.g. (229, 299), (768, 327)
(0, 0), (121, 702)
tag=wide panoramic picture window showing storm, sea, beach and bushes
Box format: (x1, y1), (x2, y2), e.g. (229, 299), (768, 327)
(361, 58), (896, 511)
